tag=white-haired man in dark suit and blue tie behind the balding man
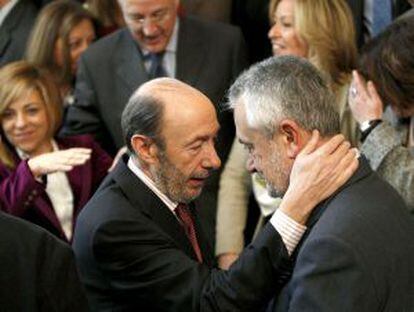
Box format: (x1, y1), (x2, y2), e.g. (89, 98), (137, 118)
(63, 0), (247, 243)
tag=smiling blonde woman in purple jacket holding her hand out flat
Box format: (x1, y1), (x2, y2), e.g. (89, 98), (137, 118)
(0, 61), (112, 242)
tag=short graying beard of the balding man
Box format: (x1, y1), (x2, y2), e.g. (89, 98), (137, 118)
(151, 151), (208, 204)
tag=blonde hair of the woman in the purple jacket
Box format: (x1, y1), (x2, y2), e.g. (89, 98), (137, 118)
(0, 61), (62, 168)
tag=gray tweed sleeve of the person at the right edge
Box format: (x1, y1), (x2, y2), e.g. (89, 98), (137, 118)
(361, 121), (414, 213)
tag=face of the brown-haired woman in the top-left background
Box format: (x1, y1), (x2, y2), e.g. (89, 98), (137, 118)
(55, 19), (96, 75)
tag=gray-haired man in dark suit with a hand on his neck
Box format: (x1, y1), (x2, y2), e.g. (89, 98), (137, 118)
(230, 56), (414, 312)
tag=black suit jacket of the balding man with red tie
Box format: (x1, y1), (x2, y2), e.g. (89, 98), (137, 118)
(73, 159), (292, 312)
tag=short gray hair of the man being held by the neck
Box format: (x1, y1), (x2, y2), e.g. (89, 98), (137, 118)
(228, 56), (340, 136)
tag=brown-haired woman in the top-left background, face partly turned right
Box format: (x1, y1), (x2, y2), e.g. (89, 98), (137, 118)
(25, 0), (96, 105)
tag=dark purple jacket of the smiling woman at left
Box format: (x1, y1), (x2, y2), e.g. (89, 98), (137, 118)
(0, 135), (112, 241)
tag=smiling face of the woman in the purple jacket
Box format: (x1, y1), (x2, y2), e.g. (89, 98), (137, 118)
(0, 91), (51, 157)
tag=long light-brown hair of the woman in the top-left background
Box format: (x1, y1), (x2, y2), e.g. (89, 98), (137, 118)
(26, 0), (94, 85)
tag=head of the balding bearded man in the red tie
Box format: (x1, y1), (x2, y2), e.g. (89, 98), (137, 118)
(122, 78), (220, 202)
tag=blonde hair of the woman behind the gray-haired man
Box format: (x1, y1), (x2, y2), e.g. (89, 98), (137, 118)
(269, 0), (357, 91)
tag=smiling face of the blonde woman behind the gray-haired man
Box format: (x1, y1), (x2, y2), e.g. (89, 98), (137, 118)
(268, 0), (308, 57)
